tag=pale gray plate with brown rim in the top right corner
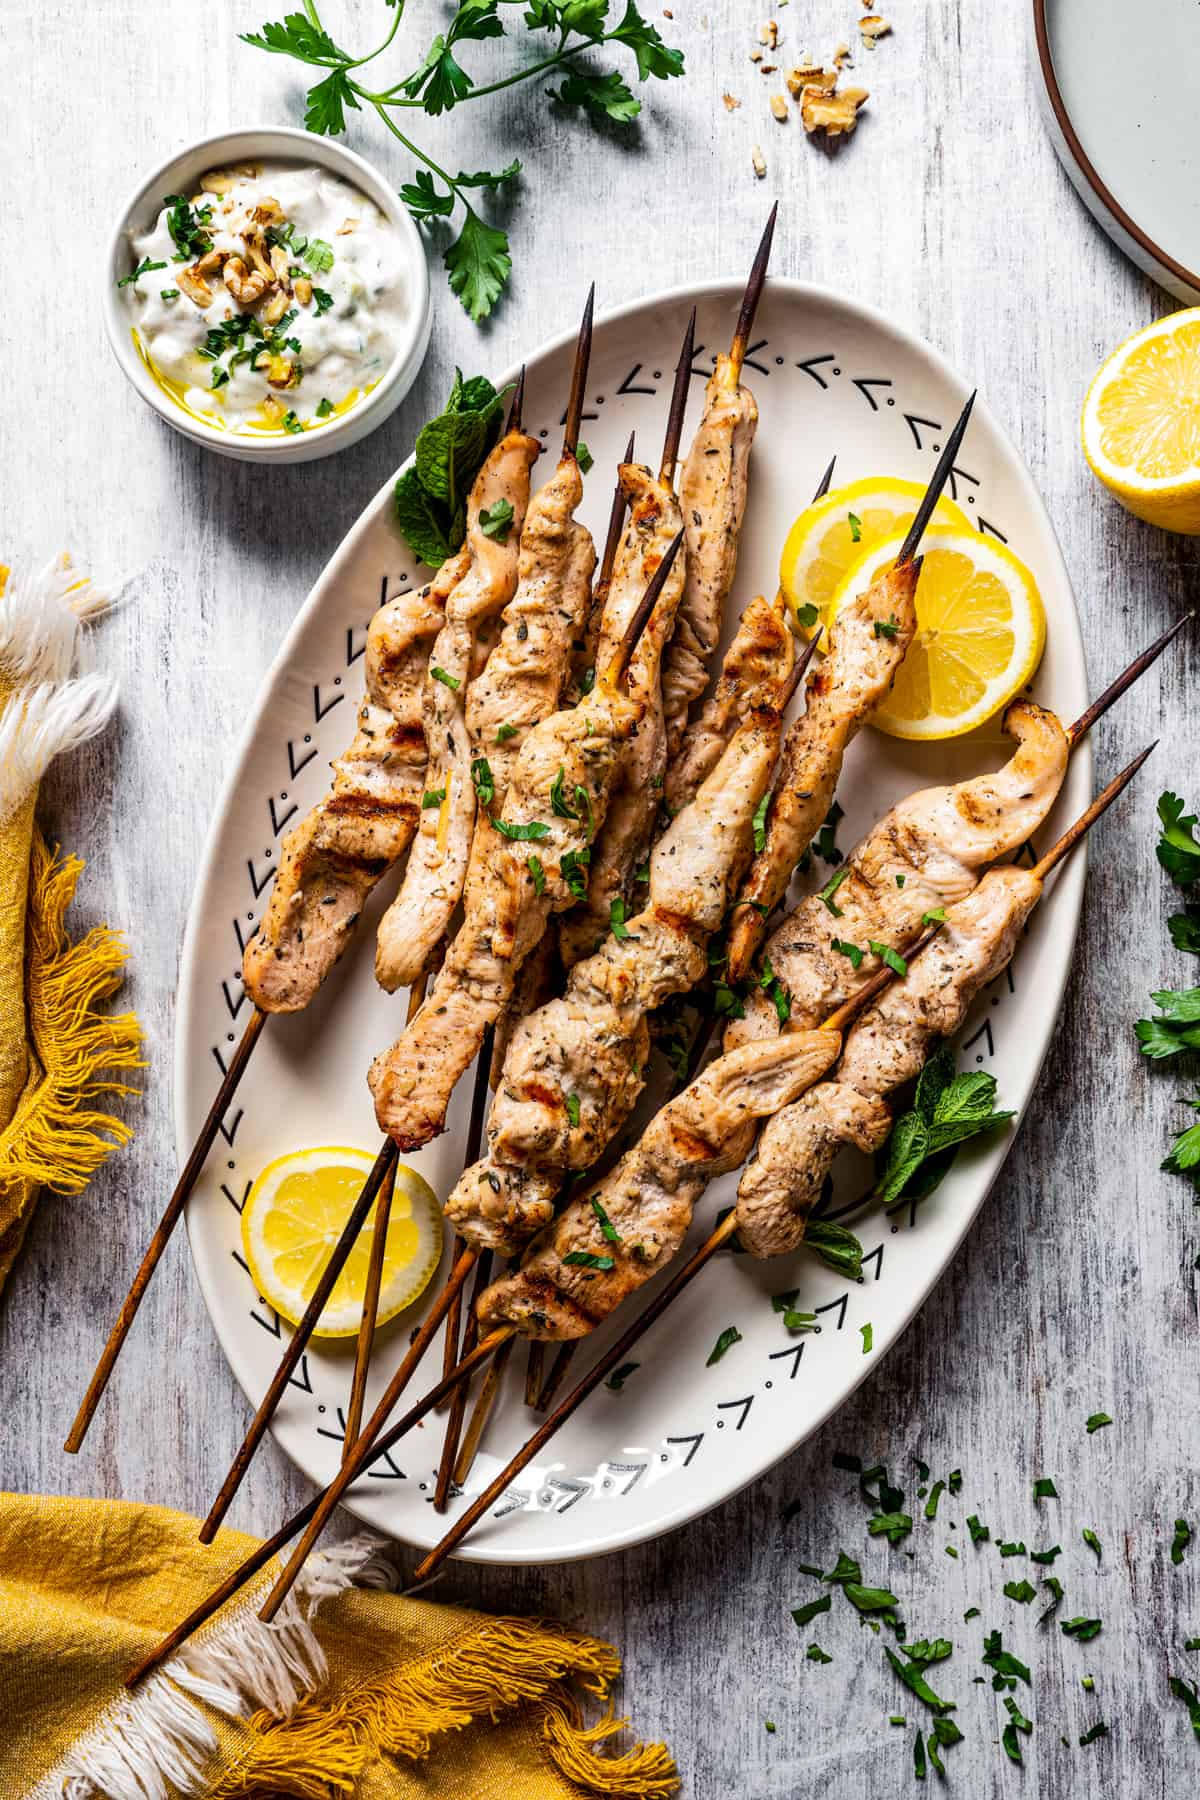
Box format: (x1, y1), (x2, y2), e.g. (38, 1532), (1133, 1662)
(1033, 0), (1200, 304)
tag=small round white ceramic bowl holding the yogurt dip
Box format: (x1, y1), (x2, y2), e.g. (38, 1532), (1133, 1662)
(103, 126), (430, 463)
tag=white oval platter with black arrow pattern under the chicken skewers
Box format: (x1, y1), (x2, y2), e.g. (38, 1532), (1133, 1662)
(176, 281), (1092, 1562)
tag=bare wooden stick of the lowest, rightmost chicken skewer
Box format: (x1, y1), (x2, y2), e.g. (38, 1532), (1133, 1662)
(412, 743), (1155, 1582)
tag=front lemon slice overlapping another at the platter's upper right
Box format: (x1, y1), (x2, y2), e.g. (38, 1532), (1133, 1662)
(831, 526), (1045, 738)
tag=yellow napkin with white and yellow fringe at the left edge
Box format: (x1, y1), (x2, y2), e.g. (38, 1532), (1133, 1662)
(0, 556), (140, 1289)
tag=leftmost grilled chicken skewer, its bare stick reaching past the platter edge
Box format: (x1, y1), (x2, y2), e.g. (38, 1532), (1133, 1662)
(63, 371), (538, 1454)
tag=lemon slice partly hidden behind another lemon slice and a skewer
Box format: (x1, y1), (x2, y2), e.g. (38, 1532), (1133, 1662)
(779, 475), (970, 635)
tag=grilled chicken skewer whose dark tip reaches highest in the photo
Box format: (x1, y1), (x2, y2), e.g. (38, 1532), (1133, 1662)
(662, 203), (779, 763)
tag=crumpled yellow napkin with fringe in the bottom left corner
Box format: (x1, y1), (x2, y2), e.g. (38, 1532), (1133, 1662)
(0, 1494), (678, 1800)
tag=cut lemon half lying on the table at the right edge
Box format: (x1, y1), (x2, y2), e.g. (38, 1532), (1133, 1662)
(1083, 306), (1200, 535)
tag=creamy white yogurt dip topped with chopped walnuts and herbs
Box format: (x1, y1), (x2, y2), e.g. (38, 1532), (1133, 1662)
(117, 162), (414, 436)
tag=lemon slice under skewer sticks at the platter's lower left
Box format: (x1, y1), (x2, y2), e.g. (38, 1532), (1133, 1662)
(241, 1143), (443, 1337)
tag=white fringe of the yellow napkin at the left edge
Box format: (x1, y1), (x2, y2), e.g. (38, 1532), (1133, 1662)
(0, 554), (117, 824)
